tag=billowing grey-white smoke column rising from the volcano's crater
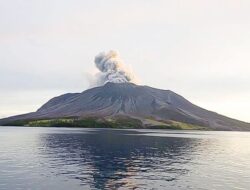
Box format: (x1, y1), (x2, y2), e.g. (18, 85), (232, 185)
(91, 50), (135, 86)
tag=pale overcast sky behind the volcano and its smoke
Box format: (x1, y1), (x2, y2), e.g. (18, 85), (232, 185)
(0, 0), (250, 122)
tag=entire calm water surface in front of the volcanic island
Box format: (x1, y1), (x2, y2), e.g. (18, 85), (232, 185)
(0, 127), (250, 190)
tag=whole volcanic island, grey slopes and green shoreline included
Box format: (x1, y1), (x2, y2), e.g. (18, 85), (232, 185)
(0, 82), (250, 131)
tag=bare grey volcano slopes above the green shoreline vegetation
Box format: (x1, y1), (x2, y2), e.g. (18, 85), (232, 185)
(0, 82), (250, 131)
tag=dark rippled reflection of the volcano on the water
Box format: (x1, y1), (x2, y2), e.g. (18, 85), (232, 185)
(40, 130), (199, 189)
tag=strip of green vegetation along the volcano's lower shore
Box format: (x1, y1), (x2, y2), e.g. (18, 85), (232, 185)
(2, 116), (208, 130)
